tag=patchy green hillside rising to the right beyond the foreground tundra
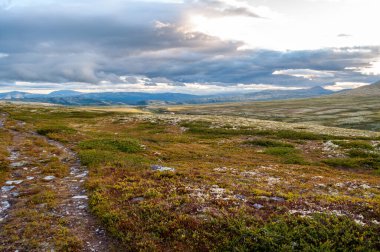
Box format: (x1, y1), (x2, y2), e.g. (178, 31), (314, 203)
(157, 80), (380, 131)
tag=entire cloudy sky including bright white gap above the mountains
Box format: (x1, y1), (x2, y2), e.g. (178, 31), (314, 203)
(0, 0), (380, 94)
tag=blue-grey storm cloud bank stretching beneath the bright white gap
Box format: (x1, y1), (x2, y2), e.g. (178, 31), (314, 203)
(0, 0), (380, 92)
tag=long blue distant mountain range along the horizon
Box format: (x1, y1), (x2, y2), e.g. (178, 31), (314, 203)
(0, 87), (333, 106)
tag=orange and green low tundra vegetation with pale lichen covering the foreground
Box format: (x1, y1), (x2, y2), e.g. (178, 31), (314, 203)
(0, 104), (380, 251)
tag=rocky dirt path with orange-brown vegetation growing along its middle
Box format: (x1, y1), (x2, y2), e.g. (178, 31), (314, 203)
(0, 115), (114, 251)
